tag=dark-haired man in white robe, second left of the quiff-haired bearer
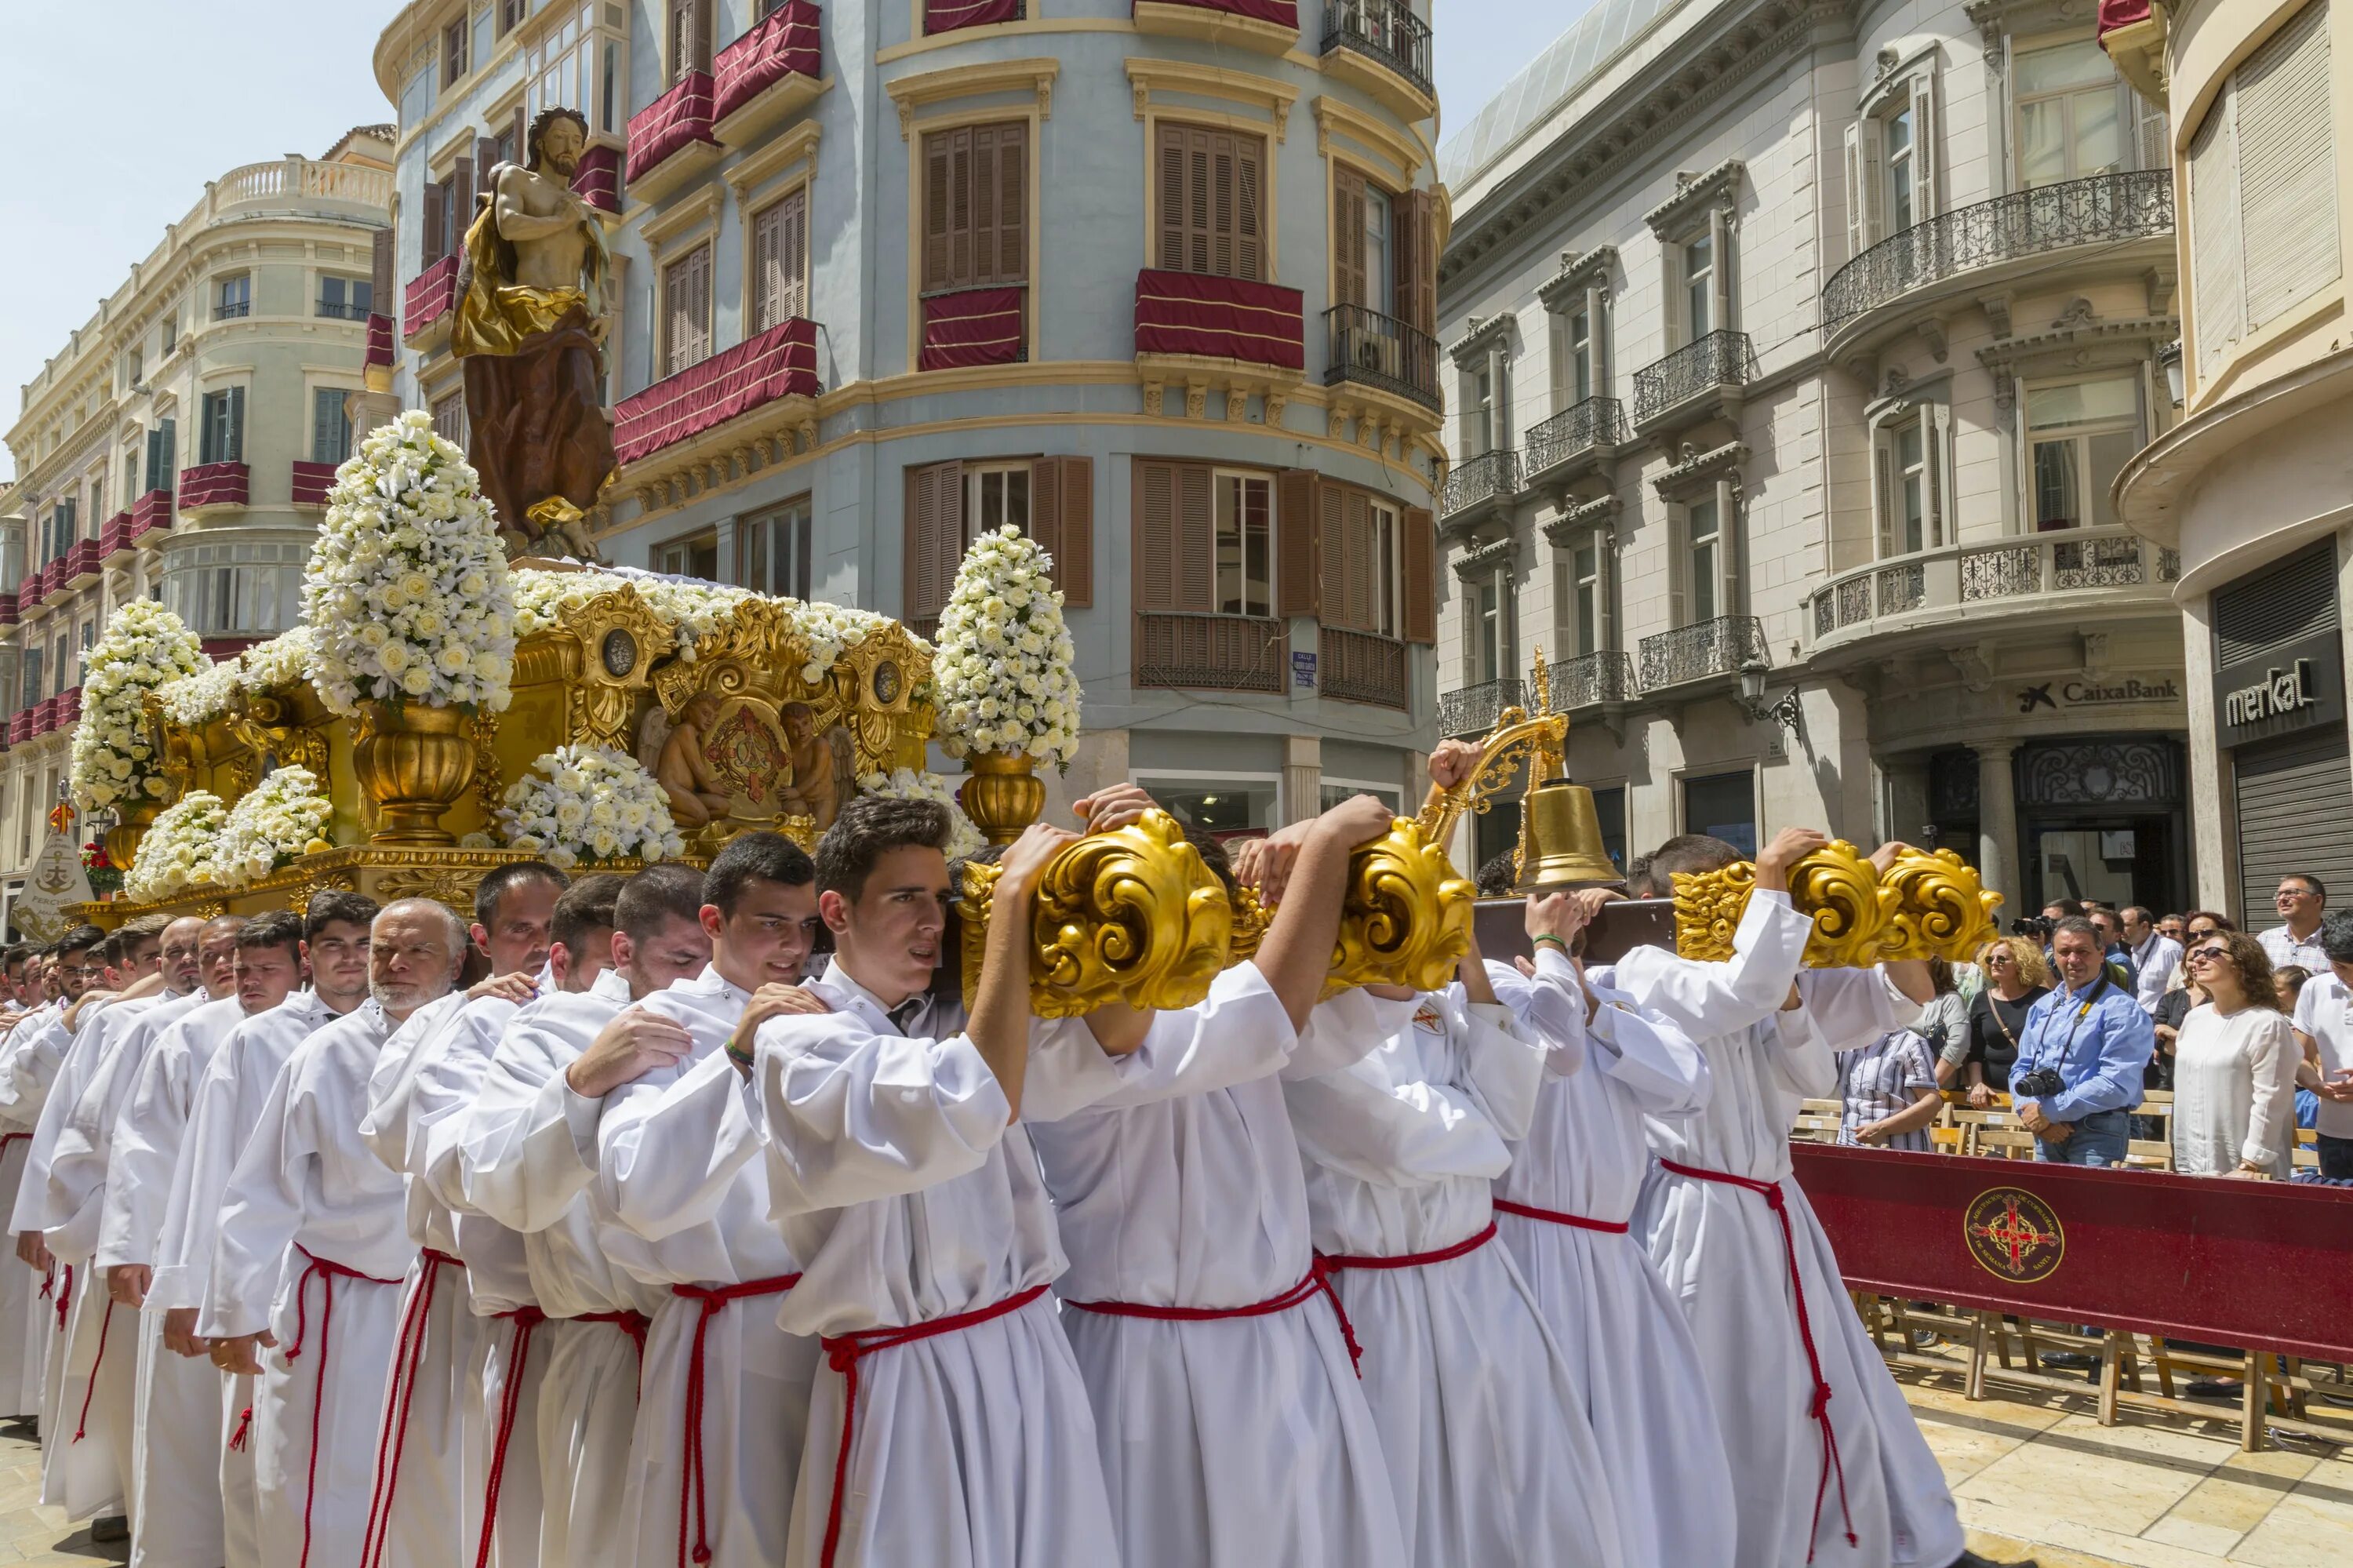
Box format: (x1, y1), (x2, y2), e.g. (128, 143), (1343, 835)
(447, 864), (711, 1568)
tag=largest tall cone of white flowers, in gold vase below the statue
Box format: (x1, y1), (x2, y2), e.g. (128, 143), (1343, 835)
(304, 409), (515, 713)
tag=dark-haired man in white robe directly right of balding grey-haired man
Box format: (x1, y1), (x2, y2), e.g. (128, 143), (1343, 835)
(360, 860), (567, 1568)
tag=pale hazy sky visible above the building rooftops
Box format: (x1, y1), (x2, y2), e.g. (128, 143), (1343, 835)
(0, 0), (1593, 473)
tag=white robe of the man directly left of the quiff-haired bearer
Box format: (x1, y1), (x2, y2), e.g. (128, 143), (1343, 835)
(598, 968), (816, 1568)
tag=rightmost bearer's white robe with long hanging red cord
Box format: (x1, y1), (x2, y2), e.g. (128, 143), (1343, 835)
(1595, 893), (1962, 1568)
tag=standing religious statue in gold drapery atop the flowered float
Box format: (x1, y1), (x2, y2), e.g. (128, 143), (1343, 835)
(449, 108), (614, 560)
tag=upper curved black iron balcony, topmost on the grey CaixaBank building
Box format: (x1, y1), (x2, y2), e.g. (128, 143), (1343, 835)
(1821, 169), (2174, 332)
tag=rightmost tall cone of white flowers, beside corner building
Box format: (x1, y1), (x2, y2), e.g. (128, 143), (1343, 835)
(932, 527), (1078, 767)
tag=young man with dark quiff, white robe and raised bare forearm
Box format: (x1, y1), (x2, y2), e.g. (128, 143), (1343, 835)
(748, 796), (1162, 1568)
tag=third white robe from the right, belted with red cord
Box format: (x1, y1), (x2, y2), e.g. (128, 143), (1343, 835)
(1282, 989), (1624, 1568)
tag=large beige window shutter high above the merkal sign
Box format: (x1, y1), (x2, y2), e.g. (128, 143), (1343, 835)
(2231, 5), (2344, 332)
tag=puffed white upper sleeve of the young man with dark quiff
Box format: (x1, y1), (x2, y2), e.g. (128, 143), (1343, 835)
(753, 1013), (1012, 1215)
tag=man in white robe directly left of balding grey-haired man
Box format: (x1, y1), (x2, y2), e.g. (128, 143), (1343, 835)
(148, 890), (379, 1568)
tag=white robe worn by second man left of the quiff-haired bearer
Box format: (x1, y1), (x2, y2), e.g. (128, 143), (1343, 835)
(447, 970), (671, 1568)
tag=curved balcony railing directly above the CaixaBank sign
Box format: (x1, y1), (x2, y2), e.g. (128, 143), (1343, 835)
(1805, 527), (2181, 652)
